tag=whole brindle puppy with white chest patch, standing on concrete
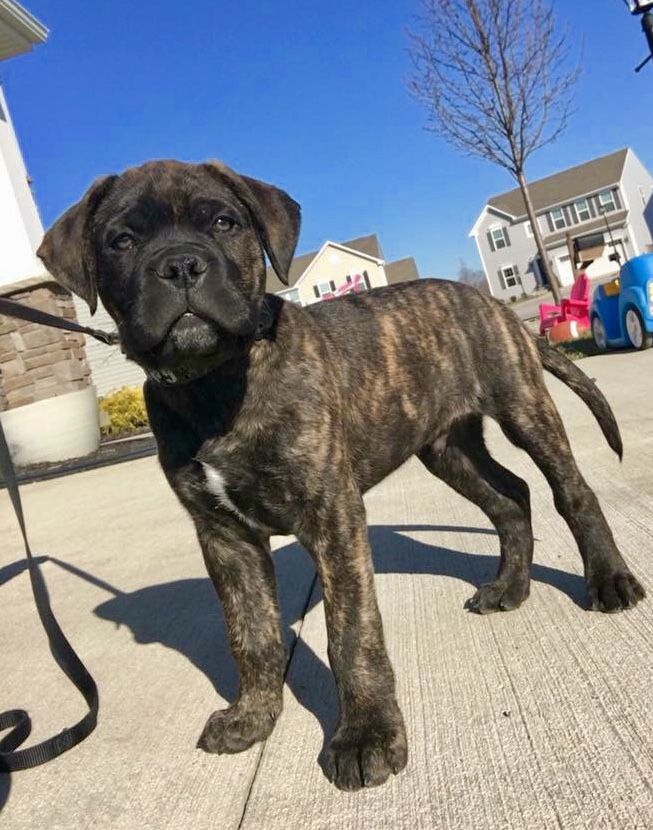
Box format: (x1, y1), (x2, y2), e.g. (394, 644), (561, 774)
(39, 161), (644, 789)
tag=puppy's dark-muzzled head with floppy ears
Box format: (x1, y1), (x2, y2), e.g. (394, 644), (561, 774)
(38, 161), (300, 369)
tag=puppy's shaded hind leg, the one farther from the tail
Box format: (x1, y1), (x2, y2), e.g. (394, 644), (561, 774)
(418, 415), (533, 614)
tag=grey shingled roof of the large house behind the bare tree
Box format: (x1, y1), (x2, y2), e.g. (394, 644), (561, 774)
(488, 147), (628, 217)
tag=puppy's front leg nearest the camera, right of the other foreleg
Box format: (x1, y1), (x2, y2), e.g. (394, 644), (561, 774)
(298, 482), (407, 790)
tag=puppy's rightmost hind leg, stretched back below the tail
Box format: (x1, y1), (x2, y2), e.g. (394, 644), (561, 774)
(498, 384), (645, 611)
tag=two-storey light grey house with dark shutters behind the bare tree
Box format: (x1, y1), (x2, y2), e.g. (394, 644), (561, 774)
(469, 148), (653, 300)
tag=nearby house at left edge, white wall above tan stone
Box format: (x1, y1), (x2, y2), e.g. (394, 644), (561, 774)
(0, 0), (100, 465)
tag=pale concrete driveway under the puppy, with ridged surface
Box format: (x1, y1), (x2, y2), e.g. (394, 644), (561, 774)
(0, 352), (653, 830)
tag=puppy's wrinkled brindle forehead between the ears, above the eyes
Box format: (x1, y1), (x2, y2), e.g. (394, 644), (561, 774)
(95, 162), (247, 227)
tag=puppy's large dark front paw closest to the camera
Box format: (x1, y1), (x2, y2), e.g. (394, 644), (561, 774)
(322, 709), (408, 790)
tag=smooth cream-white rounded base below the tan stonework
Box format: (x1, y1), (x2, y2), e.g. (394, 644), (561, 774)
(0, 386), (100, 467)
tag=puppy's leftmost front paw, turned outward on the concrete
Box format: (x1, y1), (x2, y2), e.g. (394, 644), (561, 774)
(197, 702), (281, 755)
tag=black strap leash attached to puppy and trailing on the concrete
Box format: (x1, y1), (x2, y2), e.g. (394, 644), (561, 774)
(0, 297), (118, 772)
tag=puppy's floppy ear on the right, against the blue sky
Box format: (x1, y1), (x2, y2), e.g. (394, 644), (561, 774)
(207, 161), (301, 285)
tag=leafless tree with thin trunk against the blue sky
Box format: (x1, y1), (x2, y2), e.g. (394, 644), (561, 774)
(409, 0), (578, 301)
